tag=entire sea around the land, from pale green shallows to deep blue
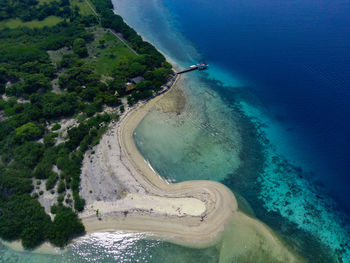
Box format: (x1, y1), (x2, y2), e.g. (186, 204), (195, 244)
(0, 0), (350, 263)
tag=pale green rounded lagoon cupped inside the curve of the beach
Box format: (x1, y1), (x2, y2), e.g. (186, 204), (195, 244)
(135, 73), (242, 185)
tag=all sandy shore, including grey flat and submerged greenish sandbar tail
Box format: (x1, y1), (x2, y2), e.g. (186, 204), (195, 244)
(4, 69), (303, 262)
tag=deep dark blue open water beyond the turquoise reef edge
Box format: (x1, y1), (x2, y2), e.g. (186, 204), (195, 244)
(163, 0), (350, 214)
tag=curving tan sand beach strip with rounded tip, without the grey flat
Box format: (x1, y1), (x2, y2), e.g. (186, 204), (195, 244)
(81, 73), (238, 247)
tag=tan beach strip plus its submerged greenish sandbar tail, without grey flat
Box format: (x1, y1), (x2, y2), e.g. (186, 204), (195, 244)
(78, 71), (304, 262)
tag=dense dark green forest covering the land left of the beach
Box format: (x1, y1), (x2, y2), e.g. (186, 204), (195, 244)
(0, 0), (172, 248)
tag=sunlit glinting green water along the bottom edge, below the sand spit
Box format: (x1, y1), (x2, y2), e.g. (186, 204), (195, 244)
(0, 232), (219, 263)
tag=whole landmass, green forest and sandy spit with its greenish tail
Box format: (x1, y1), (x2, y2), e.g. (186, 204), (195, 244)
(0, 0), (301, 262)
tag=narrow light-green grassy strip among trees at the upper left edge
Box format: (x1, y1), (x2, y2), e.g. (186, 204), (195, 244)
(0, 16), (63, 29)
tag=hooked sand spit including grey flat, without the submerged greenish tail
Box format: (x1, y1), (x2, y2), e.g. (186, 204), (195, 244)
(80, 75), (237, 247)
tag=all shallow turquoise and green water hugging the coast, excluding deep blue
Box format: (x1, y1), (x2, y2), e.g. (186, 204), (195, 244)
(0, 0), (350, 262)
